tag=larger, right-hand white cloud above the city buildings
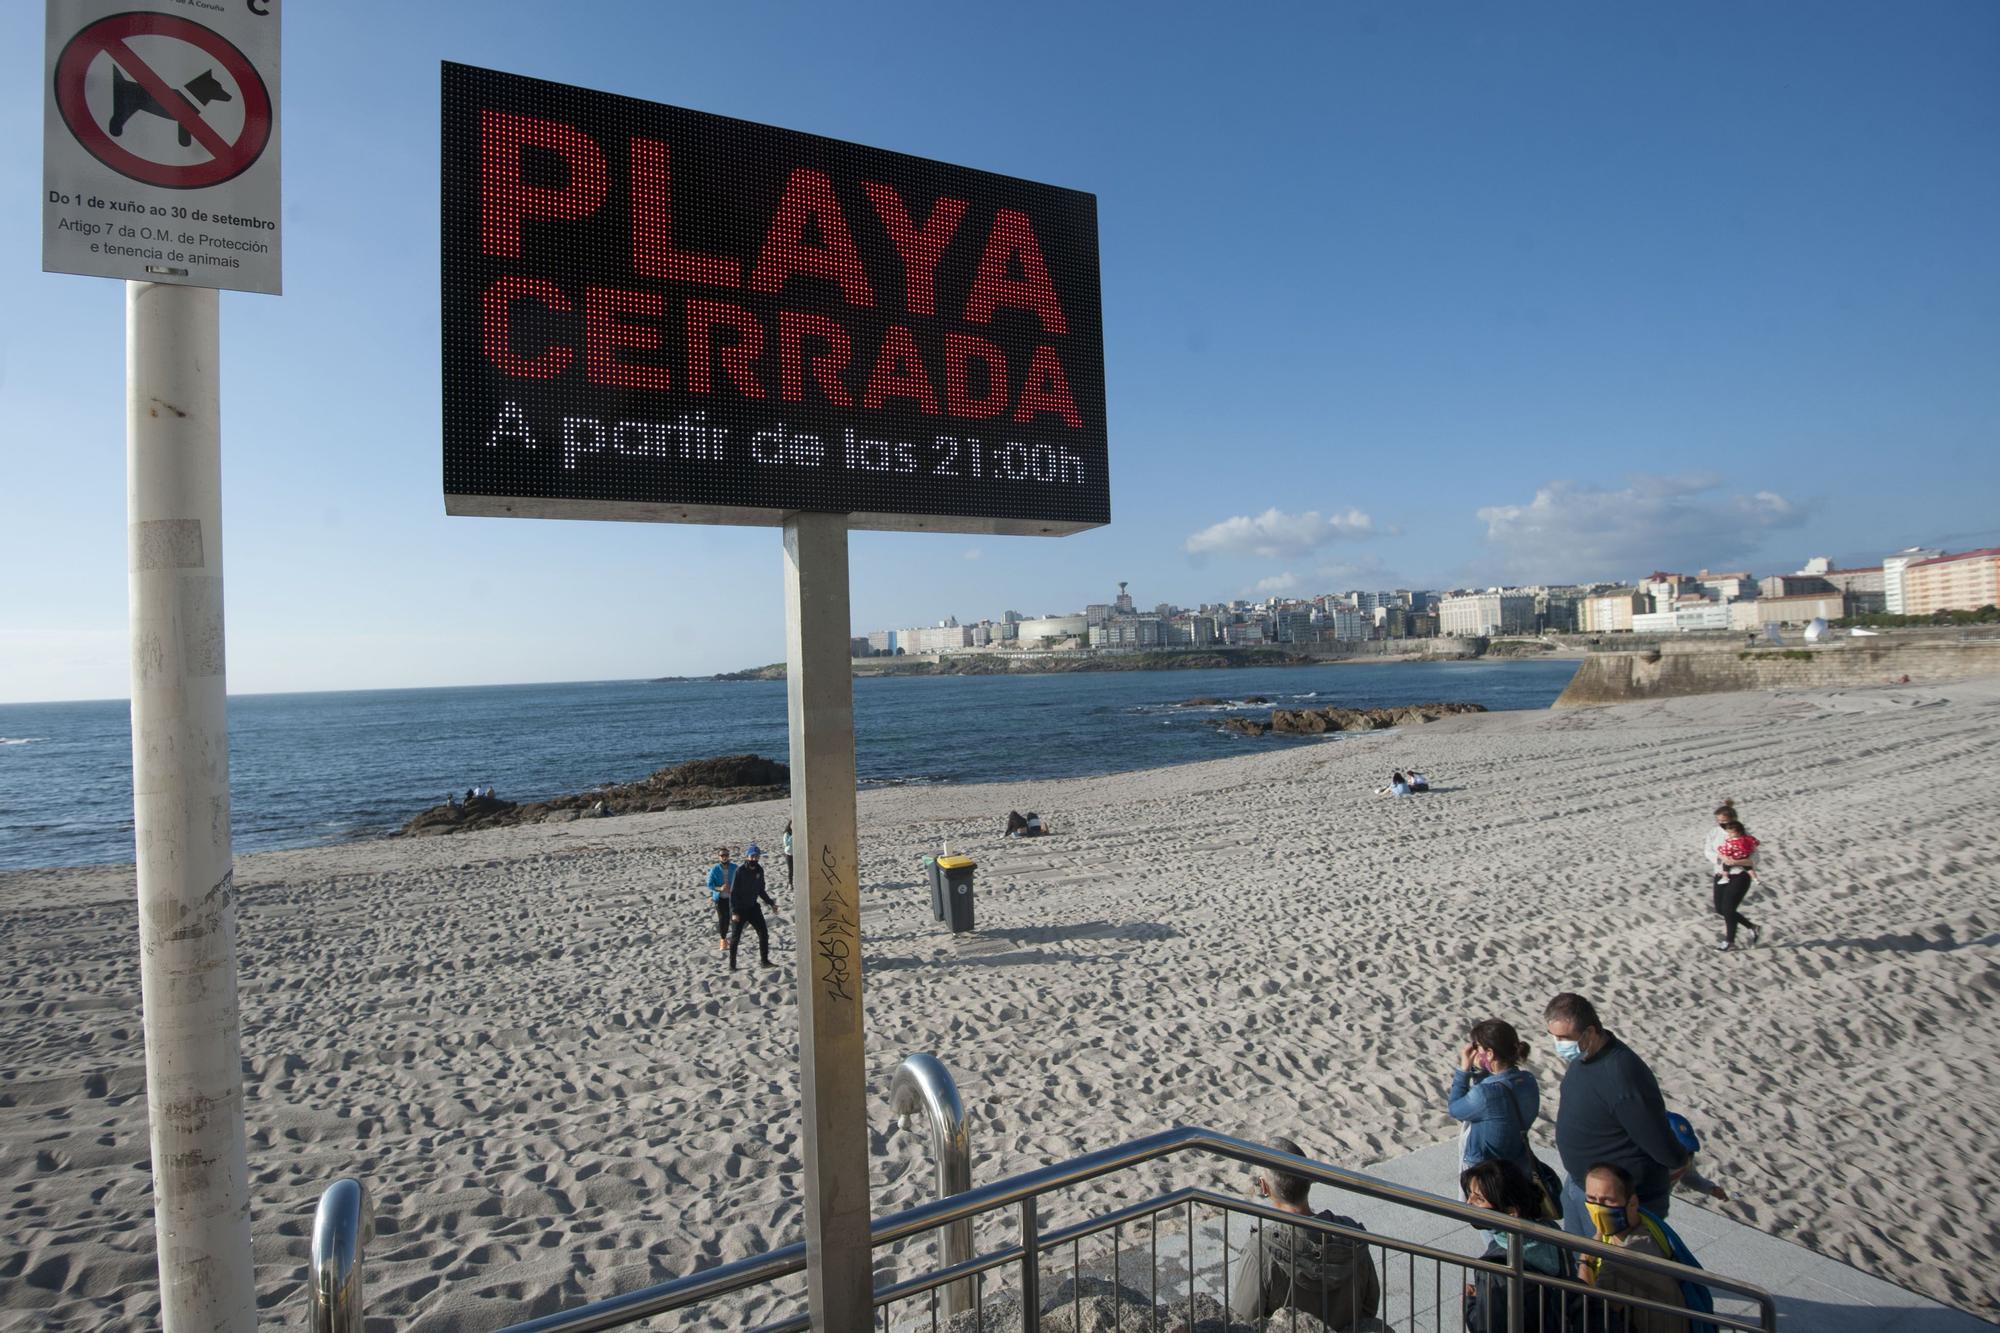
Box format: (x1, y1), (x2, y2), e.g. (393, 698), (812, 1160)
(1478, 474), (1806, 580)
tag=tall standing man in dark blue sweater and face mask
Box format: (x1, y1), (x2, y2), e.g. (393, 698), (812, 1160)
(1542, 993), (1694, 1239)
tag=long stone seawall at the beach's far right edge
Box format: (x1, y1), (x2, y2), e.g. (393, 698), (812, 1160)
(1554, 634), (2000, 709)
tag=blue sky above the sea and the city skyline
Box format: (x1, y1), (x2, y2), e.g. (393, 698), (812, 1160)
(0, 0), (2000, 701)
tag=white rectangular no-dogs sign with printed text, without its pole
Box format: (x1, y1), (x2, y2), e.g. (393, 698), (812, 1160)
(42, 0), (284, 292)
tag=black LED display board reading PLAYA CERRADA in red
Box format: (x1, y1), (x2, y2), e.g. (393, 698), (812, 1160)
(442, 64), (1110, 532)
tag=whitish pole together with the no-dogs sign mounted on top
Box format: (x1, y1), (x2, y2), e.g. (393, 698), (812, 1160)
(40, 0), (282, 1333)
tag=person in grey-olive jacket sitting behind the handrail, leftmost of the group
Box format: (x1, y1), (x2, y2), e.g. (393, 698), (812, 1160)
(1230, 1139), (1382, 1329)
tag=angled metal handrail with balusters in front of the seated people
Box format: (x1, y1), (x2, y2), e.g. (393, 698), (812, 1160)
(504, 1125), (1778, 1333)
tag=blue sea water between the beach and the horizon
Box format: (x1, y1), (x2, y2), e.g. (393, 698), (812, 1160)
(0, 662), (1576, 869)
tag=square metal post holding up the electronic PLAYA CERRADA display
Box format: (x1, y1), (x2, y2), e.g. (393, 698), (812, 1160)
(784, 512), (874, 1333)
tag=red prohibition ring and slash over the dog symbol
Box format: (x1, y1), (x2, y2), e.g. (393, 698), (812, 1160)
(56, 14), (272, 190)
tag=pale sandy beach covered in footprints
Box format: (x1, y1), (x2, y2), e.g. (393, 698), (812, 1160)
(0, 681), (2000, 1333)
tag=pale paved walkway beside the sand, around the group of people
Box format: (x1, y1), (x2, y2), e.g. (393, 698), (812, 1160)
(1280, 1143), (2000, 1333)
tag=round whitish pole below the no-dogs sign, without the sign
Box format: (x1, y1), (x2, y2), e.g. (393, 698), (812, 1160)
(126, 282), (256, 1333)
